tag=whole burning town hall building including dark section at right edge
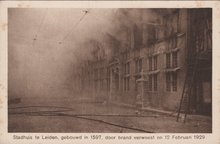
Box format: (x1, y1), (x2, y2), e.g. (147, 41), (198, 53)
(74, 8), (212, 115)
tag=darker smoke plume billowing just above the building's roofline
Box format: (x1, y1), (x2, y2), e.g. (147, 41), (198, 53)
(75, 8), (161, 64)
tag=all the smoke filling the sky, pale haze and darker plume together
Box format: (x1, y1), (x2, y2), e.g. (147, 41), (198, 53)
(8, 8), (164, 102)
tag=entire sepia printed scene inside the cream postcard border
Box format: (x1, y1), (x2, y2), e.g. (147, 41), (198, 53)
(7, 7), (213, 134)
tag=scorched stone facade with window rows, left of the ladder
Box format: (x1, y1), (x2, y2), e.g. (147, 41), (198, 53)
(75, 9), (212, 115)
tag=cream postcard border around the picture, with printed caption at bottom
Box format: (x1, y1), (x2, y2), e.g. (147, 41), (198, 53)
(0, 1), (220, 144)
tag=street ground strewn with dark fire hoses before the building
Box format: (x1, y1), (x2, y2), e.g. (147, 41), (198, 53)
(8, 97), (212, 133)
